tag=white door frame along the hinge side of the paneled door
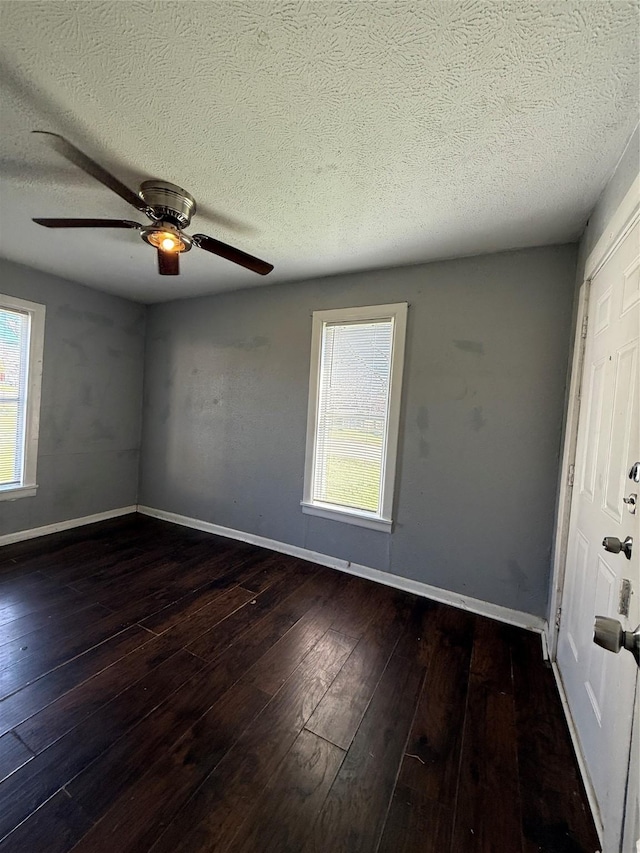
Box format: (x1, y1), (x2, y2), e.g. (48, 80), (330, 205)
(546, 173), (640, 841)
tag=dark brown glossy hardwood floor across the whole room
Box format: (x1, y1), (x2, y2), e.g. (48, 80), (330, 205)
(0, 515), (598, 853)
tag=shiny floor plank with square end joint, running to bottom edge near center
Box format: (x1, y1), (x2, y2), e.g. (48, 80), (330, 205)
(225, 729), (345, 853)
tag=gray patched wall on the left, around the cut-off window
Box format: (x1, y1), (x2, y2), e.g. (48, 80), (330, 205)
(0, 260), (146, 534)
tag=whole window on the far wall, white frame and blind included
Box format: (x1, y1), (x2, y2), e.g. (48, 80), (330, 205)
(302, 302), (407, 531)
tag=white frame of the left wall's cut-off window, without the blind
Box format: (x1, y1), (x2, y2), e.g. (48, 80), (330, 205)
(0, 293), (46, 501)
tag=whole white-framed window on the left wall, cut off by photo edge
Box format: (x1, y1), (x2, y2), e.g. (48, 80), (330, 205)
(0, 294), (45, 500)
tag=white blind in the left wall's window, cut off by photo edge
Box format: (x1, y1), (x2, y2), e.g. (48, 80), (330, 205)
(0, 307), (31, 486)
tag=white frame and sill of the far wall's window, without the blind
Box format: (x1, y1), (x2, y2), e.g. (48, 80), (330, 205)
(300, 302), (409, 533)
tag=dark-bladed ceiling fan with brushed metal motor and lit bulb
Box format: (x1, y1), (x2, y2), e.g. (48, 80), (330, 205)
(32, 130), (273, 275)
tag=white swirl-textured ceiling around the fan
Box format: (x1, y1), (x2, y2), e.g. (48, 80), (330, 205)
(0, 0), (639, 302)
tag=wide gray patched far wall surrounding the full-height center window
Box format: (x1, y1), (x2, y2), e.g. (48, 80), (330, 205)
(139, 246), (576, 615)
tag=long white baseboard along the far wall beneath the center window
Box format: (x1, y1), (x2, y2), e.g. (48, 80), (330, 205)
(138, 505), (547, 640)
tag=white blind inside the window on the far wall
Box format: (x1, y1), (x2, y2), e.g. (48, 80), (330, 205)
(313, 319), (393, 513)
